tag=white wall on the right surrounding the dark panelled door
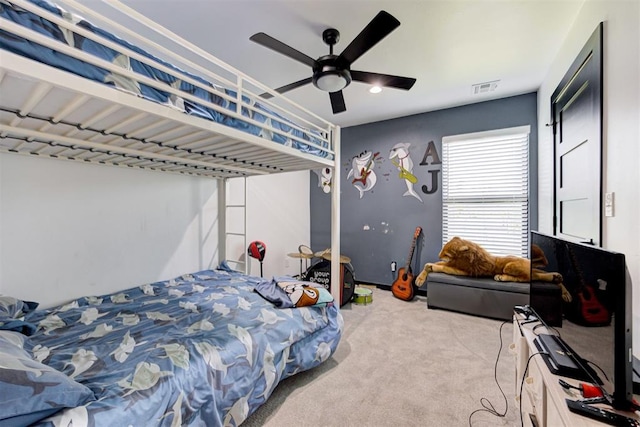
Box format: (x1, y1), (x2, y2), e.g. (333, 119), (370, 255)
(538, 0), (640, 356)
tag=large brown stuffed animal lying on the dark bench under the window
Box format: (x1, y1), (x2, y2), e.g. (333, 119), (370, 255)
(416, 237), (571, 301)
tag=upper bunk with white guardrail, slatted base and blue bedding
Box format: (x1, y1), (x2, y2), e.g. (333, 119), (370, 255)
(0, 0), (340, 178)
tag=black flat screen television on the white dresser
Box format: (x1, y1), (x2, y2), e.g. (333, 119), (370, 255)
(530, 231), (633, 409)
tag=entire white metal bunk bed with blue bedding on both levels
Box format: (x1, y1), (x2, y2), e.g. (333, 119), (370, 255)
(0, 0), (343, 426)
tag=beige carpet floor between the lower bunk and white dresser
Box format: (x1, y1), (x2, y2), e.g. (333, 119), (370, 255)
(242, 289), (520, 427)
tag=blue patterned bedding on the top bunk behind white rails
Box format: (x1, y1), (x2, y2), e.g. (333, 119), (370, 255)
(0, 0), (333, 158)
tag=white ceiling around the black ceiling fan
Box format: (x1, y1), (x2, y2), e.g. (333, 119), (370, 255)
(107, 0), (584, 127)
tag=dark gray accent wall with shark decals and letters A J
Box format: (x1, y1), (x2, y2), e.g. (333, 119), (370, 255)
(310, 93), (538, 286)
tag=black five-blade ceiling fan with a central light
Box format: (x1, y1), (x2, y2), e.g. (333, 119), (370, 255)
(249, 10), (416, 114)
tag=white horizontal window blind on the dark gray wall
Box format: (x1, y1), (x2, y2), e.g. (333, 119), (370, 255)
(442, 126), (530, 257)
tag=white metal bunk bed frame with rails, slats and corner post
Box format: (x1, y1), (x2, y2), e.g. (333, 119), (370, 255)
(0, 0), (340, 297)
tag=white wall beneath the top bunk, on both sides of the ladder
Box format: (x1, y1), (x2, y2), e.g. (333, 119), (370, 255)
(0, 154), (309, 307)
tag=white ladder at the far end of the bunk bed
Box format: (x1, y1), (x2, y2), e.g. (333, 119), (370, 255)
(219, 177), (249, 274)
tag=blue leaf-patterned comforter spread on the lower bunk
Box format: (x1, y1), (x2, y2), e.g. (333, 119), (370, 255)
(15, 270), (343, 426)
